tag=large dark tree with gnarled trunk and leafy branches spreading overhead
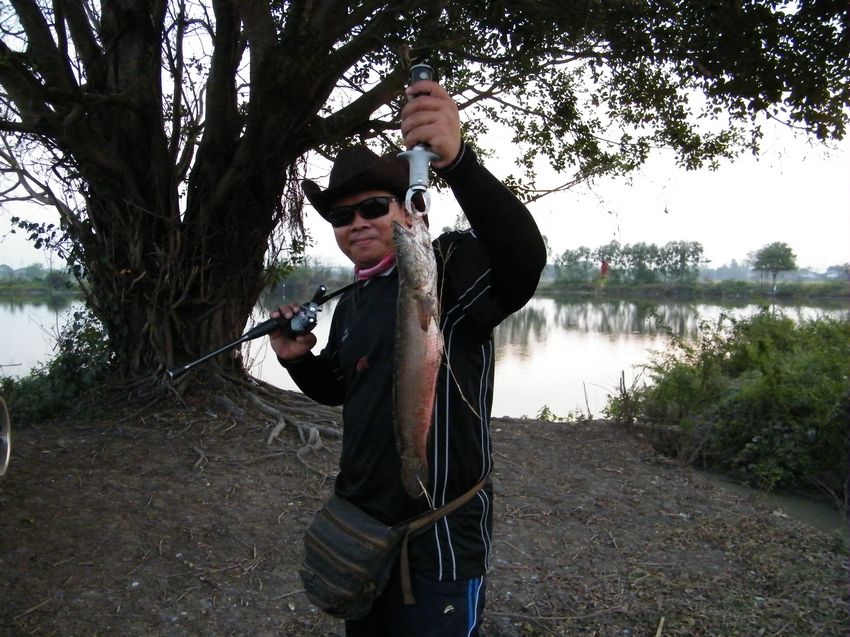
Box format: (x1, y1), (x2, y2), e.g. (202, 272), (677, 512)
(0, 0), (850, 379)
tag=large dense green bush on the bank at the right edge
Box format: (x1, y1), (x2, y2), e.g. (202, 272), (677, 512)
(606, 309), (850, 492)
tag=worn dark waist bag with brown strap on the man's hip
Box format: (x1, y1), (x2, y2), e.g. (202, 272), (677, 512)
(298, 480), (485, 619)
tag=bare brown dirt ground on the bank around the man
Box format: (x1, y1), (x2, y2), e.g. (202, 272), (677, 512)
(0, 394), (850, 637)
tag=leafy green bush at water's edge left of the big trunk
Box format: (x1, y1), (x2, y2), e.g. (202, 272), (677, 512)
(0, 311), (113, 423)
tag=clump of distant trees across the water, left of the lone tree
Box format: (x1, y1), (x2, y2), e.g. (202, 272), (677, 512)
(555, 241), (707, 284)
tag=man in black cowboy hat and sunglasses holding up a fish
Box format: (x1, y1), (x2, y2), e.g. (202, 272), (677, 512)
(270, 80), (546, 637)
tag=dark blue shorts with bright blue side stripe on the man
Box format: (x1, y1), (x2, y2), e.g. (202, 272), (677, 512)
(345, 567), (485, 637)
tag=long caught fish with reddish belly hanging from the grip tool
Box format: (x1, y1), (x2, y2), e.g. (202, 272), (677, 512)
(393, 214), (443, 498)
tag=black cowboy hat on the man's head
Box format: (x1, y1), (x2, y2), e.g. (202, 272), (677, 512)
(301, 146), (409, 217)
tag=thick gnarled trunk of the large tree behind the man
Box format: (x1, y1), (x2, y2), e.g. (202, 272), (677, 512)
(48, 2), (318, 380)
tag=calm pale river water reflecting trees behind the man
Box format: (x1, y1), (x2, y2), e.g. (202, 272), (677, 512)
(0, 296), (848, 417)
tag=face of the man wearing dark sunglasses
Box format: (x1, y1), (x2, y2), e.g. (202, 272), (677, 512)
(333, 190), (409, 269)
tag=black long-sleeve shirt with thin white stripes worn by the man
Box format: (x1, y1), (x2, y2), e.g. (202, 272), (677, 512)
(284, 147), (546, 580)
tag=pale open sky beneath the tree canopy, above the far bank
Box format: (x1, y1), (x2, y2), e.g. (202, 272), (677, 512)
(0, 119), (850, 271)
